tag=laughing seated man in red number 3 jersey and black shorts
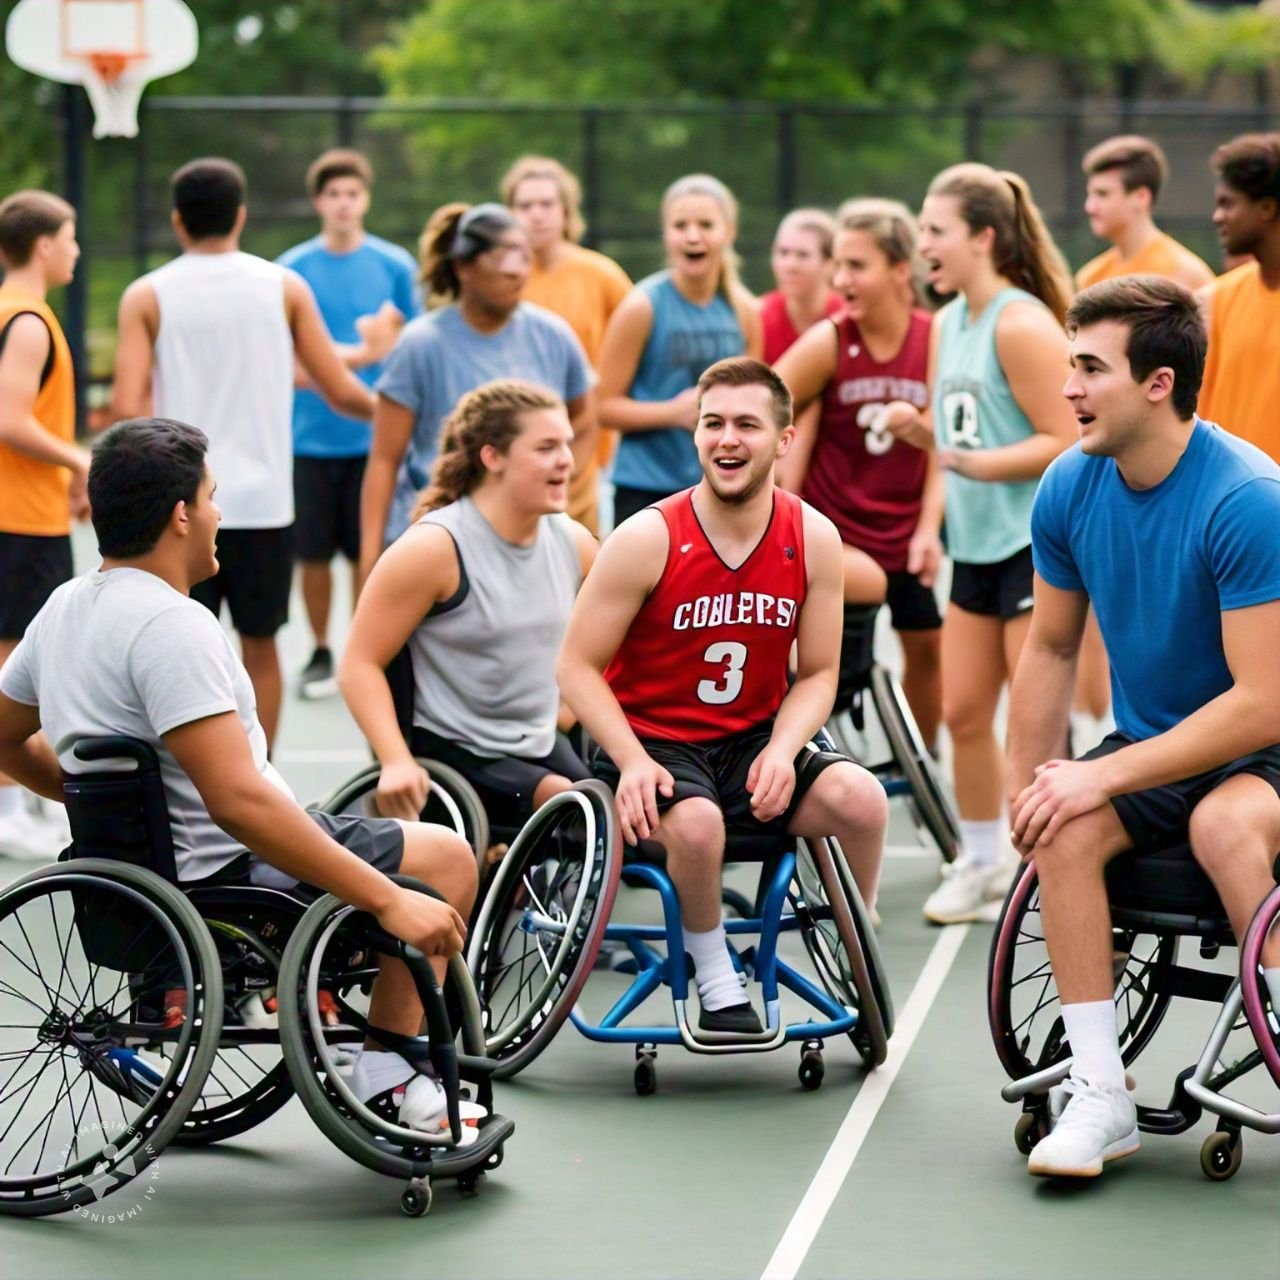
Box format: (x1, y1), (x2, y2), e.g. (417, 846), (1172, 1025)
(558, 357), (888, 1034)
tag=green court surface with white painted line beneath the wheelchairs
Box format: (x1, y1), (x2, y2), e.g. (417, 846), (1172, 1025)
(0, 552), (1280, 1280)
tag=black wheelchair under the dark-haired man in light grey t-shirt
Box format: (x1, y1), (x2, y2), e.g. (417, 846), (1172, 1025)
(0, 737), (515, 1217)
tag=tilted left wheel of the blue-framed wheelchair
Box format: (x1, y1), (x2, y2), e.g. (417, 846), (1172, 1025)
(467, 781), (621, 1079)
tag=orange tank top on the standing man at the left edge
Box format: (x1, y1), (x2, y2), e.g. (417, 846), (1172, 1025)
(0, 285), (76, 538)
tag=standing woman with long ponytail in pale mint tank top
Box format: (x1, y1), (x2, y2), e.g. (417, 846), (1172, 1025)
(884, 164), (1078, 924)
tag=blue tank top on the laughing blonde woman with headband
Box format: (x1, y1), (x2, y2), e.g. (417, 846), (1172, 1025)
(613, 271), (746, 494)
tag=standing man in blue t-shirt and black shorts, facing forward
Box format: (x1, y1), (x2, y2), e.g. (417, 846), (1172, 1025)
(276, 147), (419, 698)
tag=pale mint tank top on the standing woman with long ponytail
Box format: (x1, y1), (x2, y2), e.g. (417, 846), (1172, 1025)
(933, 289), (1043, 564)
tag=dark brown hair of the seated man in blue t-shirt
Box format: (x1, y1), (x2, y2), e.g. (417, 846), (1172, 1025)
(1066, 275), (1208, 420)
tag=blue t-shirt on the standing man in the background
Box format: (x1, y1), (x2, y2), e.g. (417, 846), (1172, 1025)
(276, 236), (421, 458)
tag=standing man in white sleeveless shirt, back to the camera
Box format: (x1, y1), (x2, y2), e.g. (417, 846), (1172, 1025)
(113, 157), (374, 744)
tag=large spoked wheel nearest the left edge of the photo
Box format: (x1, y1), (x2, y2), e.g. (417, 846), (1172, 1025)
(0, 858), (223, 1219)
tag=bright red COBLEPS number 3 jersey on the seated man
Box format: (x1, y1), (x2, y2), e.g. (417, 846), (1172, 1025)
(604, 489), (808, 742)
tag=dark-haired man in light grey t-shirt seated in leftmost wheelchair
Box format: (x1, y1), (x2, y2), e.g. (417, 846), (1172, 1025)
(0, 419), (476, 1128)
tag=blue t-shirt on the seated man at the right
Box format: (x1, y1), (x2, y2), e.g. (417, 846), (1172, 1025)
(1032, 419), (1280, 740)
